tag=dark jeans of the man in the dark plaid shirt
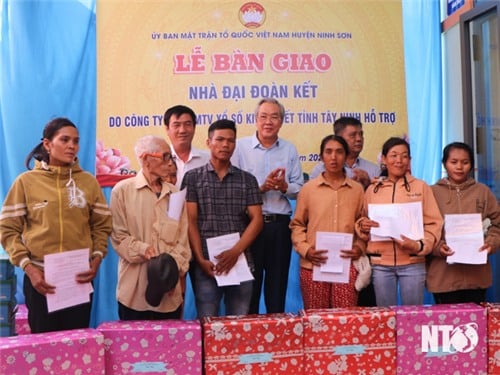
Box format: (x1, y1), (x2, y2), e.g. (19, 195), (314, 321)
(190, 262), (253, 318)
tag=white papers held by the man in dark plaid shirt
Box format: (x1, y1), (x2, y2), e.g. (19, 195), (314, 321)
(207, 233), (253, 286)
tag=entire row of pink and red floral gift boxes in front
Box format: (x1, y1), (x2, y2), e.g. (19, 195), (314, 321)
(0, 304), (500, 375)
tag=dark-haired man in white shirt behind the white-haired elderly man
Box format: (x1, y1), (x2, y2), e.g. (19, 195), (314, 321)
(163, 105), (210, 188)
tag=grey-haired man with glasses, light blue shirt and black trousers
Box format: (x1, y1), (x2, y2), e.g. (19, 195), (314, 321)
(231, 98), (304, 314)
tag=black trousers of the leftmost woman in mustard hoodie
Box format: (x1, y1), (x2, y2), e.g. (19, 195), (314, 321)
(23, 275), (92, 333)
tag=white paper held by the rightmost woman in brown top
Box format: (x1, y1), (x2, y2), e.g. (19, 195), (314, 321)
(444, 214), (488, 264)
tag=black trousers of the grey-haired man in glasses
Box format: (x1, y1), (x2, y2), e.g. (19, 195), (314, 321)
(250, 215), (292, 314)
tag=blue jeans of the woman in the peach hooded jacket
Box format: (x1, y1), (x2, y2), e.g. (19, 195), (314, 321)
(372, 263), (425, 306)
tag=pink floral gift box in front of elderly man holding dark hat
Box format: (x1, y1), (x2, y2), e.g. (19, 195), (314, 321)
(97, 320), (202, 375)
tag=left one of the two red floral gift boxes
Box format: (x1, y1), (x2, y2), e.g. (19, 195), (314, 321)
(202, 313), (303, 375)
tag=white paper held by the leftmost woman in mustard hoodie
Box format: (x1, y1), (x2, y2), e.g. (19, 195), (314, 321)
(44, 249), (93, 312)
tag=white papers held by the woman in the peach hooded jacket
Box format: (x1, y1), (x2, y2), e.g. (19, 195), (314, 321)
(368, 202), (424, 241)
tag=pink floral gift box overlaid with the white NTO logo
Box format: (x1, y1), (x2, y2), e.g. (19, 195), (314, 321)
(394, 303), (487, 375)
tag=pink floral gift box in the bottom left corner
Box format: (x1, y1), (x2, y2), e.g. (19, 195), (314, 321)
(0, 328), (104, 375)
